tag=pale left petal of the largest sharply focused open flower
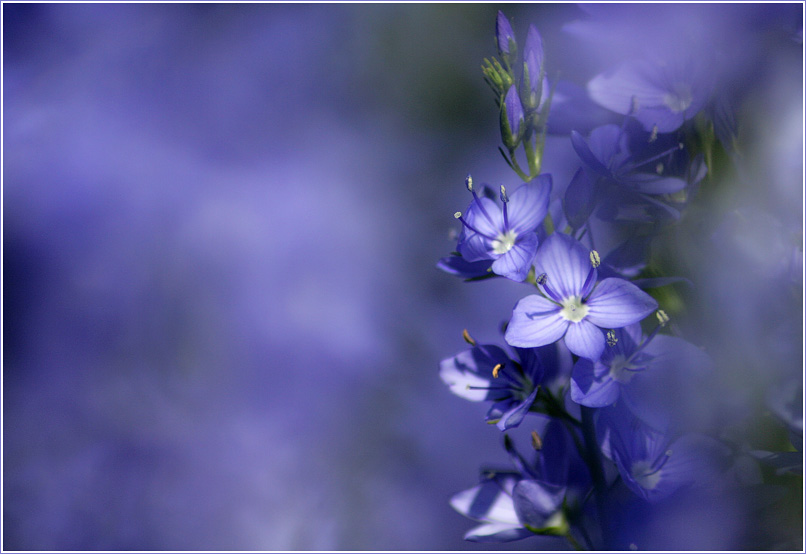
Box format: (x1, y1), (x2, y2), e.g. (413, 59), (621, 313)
(504, 294), (568, 348)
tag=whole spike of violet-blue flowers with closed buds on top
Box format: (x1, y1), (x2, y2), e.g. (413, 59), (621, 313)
(438, 8), (802, 549)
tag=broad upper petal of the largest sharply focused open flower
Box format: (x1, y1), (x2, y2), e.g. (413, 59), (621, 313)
(535, 233), (591, 298)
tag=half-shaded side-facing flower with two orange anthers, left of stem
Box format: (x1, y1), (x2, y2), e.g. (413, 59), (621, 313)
(439, 334), (561, 431)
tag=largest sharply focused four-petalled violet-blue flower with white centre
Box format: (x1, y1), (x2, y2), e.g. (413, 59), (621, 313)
(505, 233), (658, 360)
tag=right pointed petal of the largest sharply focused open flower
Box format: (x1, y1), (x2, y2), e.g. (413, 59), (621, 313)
(584, 277), (658, 328)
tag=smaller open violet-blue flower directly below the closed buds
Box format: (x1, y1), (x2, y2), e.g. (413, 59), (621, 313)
(456, 175), (551, 281)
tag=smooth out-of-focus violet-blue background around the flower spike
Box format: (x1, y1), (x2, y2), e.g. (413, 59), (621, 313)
(2, 4), (803, 550)
